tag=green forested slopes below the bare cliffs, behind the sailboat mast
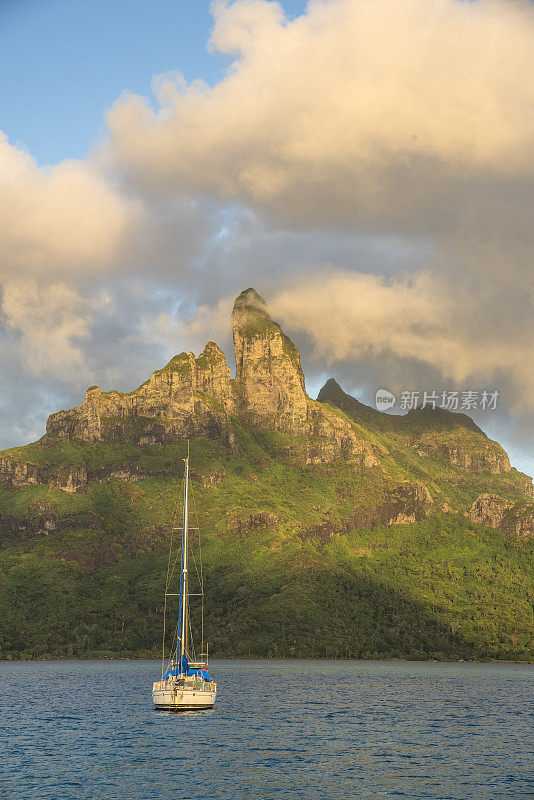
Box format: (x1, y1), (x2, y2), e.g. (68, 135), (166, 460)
(0, 426), (534, 661)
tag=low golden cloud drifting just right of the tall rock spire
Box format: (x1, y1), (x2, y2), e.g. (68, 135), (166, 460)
(271, 271), (534, 413)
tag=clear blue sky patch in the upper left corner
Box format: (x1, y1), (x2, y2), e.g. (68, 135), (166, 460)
(0, 0), (306, 164)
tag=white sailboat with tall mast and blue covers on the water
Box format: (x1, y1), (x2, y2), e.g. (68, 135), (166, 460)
(152, 442), (217, 711)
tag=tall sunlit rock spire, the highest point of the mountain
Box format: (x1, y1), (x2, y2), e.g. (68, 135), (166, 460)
(232, 289), (308, 432)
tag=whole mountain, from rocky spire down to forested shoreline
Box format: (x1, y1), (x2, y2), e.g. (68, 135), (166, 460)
(0, 289), (534, 660)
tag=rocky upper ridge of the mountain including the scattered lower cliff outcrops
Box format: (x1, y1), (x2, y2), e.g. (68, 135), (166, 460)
(0, 288), (534, 536)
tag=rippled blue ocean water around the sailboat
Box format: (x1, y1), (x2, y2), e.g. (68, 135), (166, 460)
(0, 660), (534, 800)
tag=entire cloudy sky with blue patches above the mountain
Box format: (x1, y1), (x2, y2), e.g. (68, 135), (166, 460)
(0, 0), (534, 475)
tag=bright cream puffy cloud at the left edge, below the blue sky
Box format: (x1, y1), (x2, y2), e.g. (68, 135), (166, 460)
(0, 132), (135, 280)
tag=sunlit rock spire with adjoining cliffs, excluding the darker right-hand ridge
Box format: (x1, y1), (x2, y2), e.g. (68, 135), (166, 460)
(42, 289), (381, 469)
